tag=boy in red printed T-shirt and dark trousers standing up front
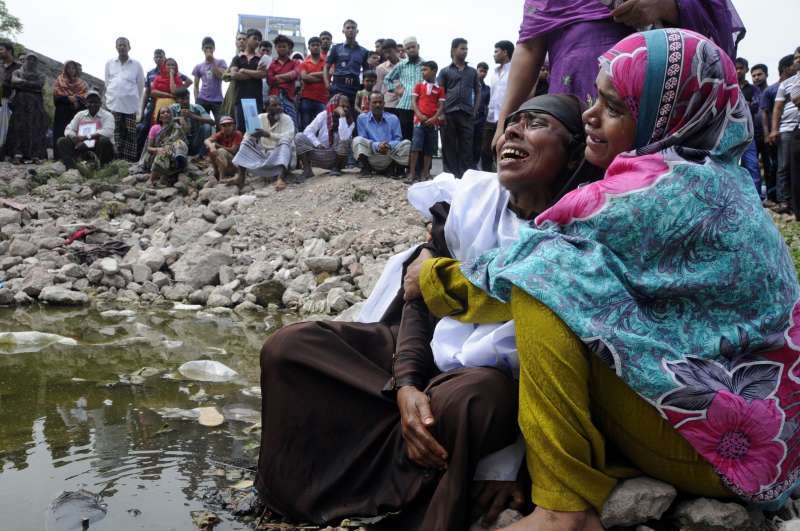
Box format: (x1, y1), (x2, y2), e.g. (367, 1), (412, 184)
(408, 61), (444, 182)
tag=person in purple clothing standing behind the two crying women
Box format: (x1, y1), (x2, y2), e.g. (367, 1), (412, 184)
(492, 0), (744, 150)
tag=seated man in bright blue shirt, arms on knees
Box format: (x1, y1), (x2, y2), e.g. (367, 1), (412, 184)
(353, 92), (411, 177)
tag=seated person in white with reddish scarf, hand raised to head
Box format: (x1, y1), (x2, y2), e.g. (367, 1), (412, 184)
(294, 94), (355, 179)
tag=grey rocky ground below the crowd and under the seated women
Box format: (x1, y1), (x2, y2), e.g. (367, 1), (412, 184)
(0, 159), (800, 531)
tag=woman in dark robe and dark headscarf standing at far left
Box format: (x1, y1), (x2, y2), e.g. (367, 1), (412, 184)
(6, 53), (49, 164)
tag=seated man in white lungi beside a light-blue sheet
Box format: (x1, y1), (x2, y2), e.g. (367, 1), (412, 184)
(227, 96), (296, 191)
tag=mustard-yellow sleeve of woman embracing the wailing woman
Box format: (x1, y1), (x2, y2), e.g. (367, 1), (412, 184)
(419, 258), (512, 324)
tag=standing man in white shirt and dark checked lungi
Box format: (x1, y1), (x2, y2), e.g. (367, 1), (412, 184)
(105, 37), (144, 162)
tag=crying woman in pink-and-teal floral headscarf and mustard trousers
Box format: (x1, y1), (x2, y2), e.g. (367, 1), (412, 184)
(406, 29), (800, 530)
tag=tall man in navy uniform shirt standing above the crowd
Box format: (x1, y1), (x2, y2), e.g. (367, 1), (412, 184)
(323, 19), (370, 108)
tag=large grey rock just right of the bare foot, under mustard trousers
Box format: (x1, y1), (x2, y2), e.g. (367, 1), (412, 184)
(600, 477), (678, 528)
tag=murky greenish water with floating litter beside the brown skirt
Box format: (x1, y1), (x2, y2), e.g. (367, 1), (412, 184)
(0, 307), (278, 531)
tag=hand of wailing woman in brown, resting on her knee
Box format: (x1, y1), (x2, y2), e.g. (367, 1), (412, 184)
(397, 385), (448, 470)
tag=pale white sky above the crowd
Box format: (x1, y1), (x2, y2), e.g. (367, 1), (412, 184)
(6, 0), (800, 89)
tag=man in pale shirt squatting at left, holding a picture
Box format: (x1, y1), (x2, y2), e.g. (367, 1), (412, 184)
(56, 90), (114, 169)
